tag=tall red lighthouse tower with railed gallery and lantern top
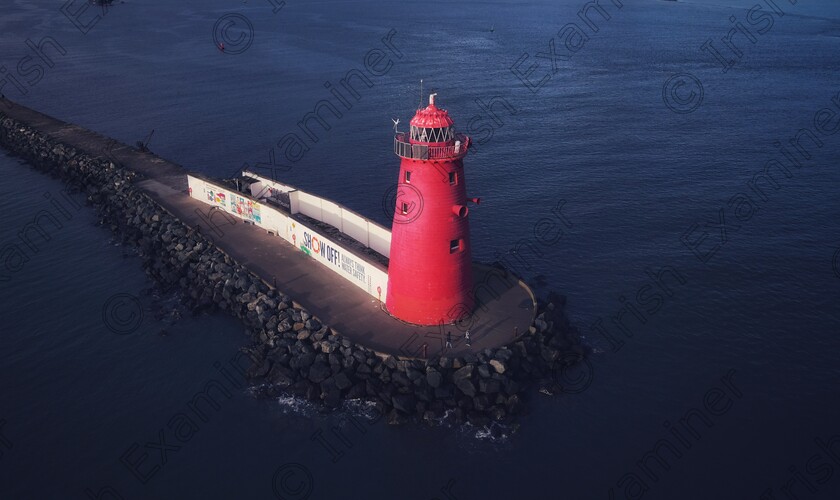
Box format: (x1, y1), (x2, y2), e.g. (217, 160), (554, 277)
(385, 94), (478, 325)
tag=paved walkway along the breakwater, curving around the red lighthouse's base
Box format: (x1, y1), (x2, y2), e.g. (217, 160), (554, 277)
(0, 101), (535, 357)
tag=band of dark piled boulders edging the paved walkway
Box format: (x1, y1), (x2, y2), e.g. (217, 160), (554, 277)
(0, 116), (591, 425)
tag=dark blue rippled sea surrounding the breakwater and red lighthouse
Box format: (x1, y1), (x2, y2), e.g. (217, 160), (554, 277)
(0, 0), (840, 500)
